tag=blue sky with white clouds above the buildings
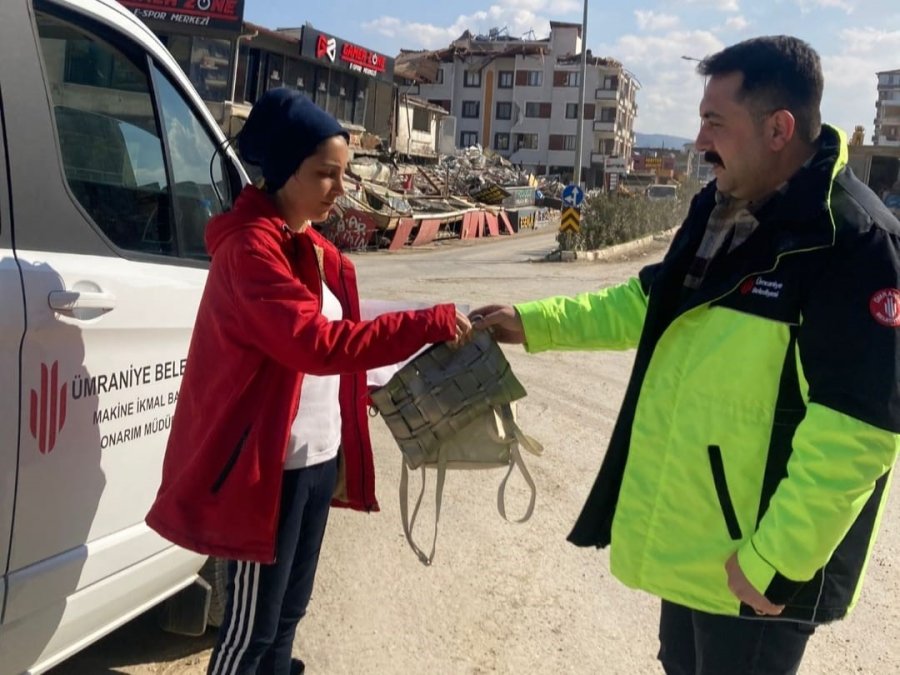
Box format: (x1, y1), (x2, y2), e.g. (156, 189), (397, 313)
(244, 0), (900, 142)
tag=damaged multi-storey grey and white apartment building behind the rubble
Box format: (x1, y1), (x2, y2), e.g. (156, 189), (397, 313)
(395, 21), (639, 187)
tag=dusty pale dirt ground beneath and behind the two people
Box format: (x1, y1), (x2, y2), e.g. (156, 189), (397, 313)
(52, 235), (900, 675)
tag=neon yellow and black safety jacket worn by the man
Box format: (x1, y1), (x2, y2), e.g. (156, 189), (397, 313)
(516, 127), (900, 623)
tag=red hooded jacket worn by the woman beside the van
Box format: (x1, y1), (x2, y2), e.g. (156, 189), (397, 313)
(147, 187), (456, 563)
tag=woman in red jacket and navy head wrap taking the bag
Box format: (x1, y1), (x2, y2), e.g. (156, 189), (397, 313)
(147, 89), (470, 675)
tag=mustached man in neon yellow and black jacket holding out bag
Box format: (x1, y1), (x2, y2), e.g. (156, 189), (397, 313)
(473, 36), (900, 675)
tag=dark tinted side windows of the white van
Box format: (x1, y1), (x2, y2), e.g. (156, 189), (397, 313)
(36, 10), (231, 258)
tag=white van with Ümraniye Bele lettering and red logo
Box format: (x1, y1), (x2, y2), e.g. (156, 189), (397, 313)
(0, 0), (247, 675)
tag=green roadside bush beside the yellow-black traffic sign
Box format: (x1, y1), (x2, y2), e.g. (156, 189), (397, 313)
(557, 186), (694, 251)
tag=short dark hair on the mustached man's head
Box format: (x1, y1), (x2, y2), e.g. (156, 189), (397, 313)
(697, 35), (825, 143)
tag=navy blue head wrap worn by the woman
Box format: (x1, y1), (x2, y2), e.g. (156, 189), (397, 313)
(238, 87), (350, 192)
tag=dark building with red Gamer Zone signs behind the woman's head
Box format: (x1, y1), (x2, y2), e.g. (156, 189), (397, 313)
(119, 0), (396, 153)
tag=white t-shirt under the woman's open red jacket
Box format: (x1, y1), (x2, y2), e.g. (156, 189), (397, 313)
(284, 282), (344, 469)
